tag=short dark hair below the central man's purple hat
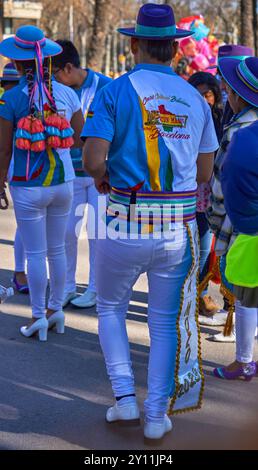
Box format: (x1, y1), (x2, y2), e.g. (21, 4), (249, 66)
(139, 39), (174, 62)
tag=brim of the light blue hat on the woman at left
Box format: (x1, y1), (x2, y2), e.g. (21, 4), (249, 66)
(0, 36), (63, 60)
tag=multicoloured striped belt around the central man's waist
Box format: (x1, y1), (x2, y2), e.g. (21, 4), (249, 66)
(107, 188), (197, 225)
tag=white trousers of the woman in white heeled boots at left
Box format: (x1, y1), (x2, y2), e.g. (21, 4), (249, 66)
(11, 181), (73, 318)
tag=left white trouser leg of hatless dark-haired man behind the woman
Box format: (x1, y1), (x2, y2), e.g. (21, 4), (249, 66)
(65, 177), (88, 294)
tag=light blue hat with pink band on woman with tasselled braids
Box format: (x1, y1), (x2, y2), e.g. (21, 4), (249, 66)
(0, 25), (62, 60)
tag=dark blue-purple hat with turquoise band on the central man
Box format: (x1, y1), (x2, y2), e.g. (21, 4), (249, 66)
(118, 3), (194, 41)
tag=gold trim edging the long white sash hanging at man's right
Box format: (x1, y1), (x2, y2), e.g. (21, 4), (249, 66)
(168, 224), (204, 415)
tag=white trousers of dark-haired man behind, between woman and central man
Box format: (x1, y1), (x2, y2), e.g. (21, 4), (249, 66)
(65, 176), (99, 294)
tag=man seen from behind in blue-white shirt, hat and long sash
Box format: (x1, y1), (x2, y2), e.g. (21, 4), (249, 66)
(82, 4), (218, 439)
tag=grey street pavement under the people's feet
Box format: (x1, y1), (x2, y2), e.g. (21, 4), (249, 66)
(0, 200), (258, 450)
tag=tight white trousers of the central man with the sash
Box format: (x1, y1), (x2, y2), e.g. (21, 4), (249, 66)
(96, 222), (196, 422)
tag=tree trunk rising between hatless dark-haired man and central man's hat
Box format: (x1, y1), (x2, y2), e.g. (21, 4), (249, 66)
(88, 0), (110, 71)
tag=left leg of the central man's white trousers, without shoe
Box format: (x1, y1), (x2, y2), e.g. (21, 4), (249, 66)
(96, 239), (148, 397)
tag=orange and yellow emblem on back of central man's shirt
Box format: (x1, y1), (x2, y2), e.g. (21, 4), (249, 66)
(145, 104), (188, 132)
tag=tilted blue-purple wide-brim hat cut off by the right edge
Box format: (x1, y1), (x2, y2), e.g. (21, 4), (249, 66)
(219, 57), (258, 108)
